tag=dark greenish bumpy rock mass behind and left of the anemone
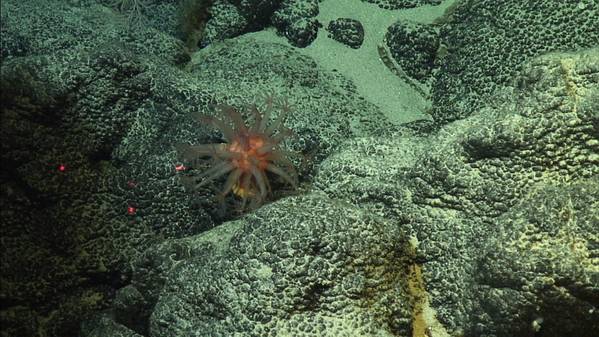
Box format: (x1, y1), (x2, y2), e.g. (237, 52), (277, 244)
(0, 0), (384, 336)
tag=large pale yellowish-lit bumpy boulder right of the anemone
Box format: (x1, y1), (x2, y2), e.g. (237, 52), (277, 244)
(315, 49), (599, 337)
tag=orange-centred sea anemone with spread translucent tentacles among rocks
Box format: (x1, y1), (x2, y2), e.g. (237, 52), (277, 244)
(177, 95), (297, 209)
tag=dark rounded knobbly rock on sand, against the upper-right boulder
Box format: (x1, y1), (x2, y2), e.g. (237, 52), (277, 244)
(385, 21), (439, 82)
